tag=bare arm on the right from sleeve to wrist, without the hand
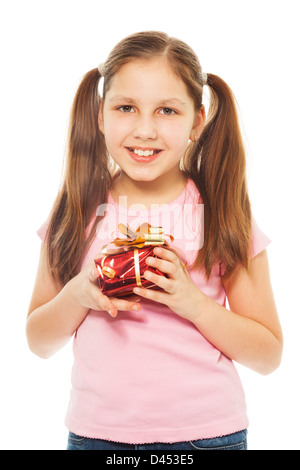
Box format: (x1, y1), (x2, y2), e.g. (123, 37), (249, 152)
(194, 251), (283, 374)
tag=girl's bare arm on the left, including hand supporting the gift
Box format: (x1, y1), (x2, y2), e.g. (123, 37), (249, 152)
(26, 244), (140, 358)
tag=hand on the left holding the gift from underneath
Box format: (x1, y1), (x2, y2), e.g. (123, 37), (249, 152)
(68, 254), (141, 317)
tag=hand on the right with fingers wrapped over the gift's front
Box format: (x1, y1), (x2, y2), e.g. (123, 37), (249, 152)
(133, 247), (204, 321)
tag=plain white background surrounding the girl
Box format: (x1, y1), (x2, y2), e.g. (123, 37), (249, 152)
(0, 0), (300, 450)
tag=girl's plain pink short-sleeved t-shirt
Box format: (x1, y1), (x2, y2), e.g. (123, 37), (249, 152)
(39, 180), (270, 444)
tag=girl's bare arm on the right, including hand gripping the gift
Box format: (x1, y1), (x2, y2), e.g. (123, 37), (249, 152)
(135, 248), (283, 374)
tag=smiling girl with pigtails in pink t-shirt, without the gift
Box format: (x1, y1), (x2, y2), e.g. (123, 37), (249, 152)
(27, 32), (282, 450)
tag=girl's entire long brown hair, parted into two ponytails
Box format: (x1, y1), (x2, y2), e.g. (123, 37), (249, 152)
(47, 31), (251, 284)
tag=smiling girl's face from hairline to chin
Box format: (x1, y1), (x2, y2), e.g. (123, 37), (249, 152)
(99, 58), (204, 182)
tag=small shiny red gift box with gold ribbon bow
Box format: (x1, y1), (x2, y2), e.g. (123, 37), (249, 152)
(95, 224), (173, 297)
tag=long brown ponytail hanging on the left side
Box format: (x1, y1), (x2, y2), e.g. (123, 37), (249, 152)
(47, 69), (111, 285)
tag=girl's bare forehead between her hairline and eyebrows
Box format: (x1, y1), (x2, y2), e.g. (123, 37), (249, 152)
(105, 57), (193, 104)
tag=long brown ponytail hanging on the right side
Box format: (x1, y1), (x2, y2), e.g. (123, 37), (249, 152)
(187, 74), (251, 279)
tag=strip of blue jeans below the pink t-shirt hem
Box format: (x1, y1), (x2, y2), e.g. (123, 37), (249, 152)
(67, 429), (247, 451)
